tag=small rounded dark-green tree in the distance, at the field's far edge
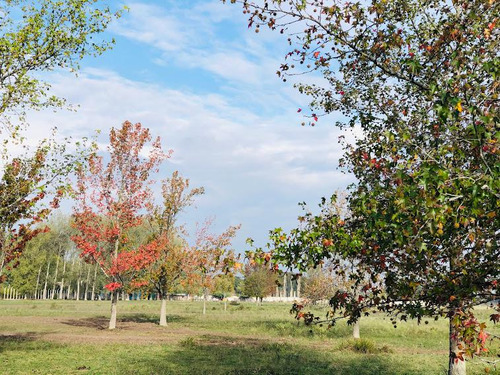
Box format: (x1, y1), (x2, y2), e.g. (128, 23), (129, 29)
(243, 263), (278, 304)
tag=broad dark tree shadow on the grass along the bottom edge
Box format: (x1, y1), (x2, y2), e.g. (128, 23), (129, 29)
(118, 335), (396, 375)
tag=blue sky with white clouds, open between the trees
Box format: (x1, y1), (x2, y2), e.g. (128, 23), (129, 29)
(24, 0), (353, 252)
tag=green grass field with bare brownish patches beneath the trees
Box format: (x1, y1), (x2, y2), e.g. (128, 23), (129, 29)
(0, 300), (500, 375)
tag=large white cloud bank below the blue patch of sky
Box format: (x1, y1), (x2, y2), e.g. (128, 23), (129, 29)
(22, 70), (349, 253)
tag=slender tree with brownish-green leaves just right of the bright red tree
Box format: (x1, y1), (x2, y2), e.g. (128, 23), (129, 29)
(146, 171), (204, 326)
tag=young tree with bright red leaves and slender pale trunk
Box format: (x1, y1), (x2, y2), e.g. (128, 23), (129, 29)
(73, 121), (170, 329)
